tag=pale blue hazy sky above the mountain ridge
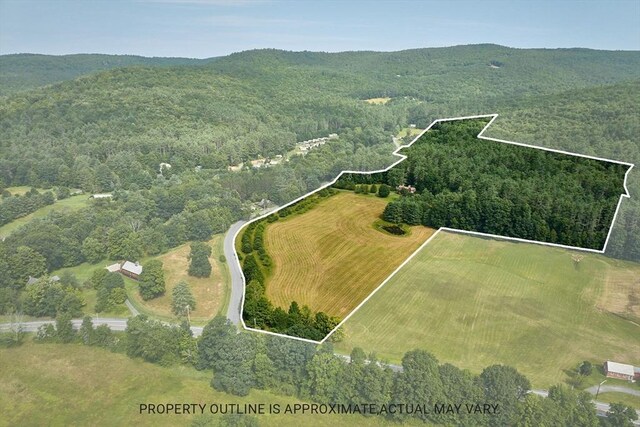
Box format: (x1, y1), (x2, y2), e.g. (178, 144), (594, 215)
(0, 0), (640, 58)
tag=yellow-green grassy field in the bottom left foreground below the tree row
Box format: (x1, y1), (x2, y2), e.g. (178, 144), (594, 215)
(0, 343), (400, 426)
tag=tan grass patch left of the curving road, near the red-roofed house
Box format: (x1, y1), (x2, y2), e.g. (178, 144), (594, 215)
(127, 234), (229, 322)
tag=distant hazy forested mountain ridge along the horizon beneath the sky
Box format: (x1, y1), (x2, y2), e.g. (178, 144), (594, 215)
(0, 44), (640, 99)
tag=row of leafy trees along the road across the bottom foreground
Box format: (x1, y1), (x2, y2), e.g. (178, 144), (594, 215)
(13, 315), (637, 427)
